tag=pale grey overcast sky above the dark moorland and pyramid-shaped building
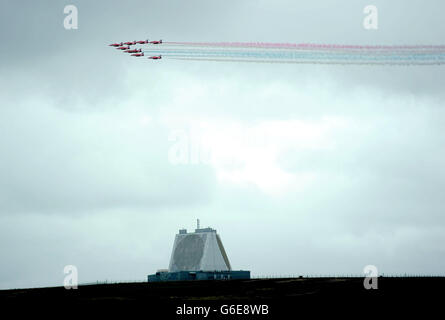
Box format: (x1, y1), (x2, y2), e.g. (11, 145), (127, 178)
(0, 0), (445, 289)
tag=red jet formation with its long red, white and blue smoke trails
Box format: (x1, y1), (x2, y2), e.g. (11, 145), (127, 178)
(109, 40), (445, 66)
